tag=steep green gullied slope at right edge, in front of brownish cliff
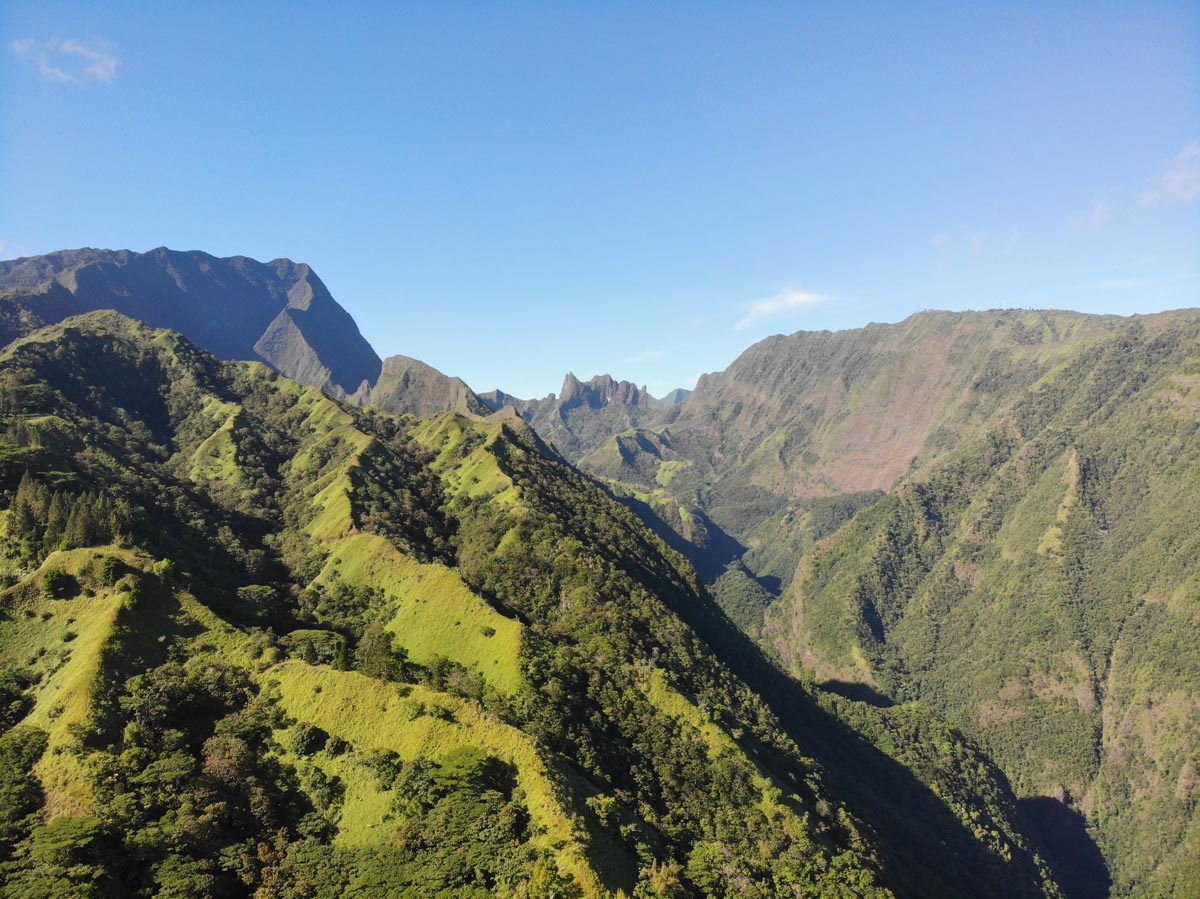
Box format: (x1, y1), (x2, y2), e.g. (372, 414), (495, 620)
(768, 312), (1200, 897)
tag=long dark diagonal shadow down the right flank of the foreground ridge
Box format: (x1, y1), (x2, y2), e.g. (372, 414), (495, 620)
(506, 444), (1070, 899)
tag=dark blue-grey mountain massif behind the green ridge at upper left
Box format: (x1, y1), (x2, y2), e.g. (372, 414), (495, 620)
(0, 247), (380, 395)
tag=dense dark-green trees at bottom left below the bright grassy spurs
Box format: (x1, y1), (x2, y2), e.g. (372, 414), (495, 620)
(0, 643), (580, 899)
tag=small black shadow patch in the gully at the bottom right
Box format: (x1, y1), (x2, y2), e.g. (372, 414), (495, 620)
(1020, 796), (1112, 899)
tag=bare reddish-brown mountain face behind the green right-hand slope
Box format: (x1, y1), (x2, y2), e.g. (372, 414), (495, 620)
(672, 310), (1120, 497)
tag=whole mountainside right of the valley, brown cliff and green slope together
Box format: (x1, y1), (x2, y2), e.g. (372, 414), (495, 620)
(549, 310), (1200, 897)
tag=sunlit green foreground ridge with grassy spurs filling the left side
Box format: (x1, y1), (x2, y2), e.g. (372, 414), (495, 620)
(0, 313), (1058, 898)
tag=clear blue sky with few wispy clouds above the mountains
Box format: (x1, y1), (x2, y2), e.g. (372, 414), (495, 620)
(0, 0), (1200, 396)
